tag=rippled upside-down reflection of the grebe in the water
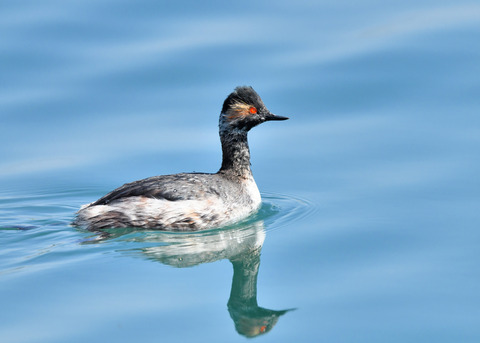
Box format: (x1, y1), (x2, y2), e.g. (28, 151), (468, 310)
(84, 220), (289, 337)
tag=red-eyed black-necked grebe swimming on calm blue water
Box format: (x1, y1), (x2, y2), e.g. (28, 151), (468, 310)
(74, 86), (288, 231)
